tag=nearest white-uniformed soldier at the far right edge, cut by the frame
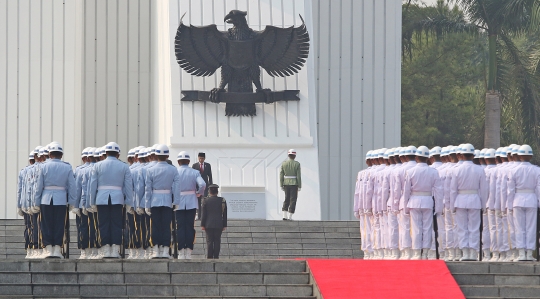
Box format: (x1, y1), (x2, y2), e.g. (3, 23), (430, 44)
(508, 144), (540, 261)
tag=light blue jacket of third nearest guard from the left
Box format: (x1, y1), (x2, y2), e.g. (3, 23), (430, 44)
(144, 162), (180, 208)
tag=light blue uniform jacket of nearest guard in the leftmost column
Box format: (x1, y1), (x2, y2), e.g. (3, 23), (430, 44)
(35, 159), (77, 206)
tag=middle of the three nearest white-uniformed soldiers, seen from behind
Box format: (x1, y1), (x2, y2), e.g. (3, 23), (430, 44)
(450, 144), (487, 261)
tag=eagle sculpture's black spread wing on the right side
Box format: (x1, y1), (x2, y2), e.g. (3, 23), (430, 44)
(254, 16), (309, 77)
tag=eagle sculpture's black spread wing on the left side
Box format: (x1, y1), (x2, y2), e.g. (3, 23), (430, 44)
(174, 23), (227, 76)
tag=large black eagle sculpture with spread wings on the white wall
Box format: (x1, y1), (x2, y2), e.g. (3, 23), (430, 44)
(175, 10), (309, 116)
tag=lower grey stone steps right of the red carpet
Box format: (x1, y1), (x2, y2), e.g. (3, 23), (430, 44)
(447, 262), (540, 299)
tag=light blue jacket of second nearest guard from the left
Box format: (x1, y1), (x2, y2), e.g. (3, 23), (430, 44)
(89, 156), (133, 206)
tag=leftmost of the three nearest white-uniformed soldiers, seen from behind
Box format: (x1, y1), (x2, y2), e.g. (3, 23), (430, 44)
(403, 146), (442, 260)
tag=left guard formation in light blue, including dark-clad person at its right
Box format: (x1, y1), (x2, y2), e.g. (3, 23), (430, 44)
(17, 142), (227, 259)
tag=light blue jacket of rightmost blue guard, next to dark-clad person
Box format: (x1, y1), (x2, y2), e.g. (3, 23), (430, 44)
(174, 165), (206, 210)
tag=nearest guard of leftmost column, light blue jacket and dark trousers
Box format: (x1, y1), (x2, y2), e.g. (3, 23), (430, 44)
(34, 143), (77, 258)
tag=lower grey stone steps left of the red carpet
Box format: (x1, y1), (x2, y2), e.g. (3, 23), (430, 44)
(0, 260), (316, 299)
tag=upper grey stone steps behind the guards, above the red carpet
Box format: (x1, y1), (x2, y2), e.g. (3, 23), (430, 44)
(0, 219), (363, 260)
